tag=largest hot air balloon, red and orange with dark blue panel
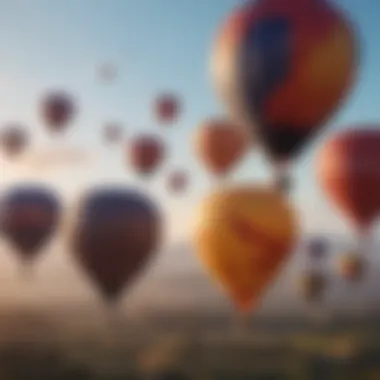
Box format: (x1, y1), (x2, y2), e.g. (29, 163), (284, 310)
(211, 0), (358, 190)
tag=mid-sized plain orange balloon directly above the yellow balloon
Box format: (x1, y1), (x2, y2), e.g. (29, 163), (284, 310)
(194, 119), (250, 178)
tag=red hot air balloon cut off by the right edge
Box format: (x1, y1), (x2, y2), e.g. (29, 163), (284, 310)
(317, 126), (380, 254)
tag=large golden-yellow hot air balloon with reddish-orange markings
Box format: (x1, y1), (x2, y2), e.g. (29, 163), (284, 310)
(195, 186), (298, 313)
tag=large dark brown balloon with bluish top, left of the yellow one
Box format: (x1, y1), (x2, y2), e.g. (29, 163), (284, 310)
(69, 187), (162, 302)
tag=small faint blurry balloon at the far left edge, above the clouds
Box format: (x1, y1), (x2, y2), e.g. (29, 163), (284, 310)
(0, 124), (29, 158)
